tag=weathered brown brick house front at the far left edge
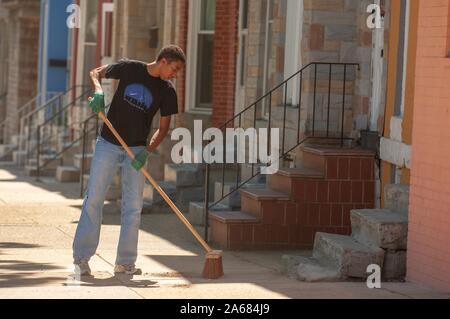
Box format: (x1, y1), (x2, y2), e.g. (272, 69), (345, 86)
(0, 0), (40, 145)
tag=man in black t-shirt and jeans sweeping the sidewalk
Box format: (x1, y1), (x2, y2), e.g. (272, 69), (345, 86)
(73, 45), (186, 275)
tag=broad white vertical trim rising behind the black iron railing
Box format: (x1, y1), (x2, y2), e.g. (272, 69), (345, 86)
(284, 0), (304, 105)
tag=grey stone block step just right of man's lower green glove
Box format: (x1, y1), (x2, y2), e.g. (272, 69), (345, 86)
(164, 164), (205, 187)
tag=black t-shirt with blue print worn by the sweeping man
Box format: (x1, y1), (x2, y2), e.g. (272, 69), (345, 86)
(101, 59), (178, 146)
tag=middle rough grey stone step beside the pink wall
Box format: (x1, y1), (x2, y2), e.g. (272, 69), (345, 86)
(313, 232), (385, 279)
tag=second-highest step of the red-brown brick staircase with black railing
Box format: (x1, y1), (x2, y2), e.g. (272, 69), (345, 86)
(268, 167), (324, 200)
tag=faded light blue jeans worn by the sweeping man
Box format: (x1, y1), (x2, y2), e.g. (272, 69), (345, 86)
(73, 137), (145, 265)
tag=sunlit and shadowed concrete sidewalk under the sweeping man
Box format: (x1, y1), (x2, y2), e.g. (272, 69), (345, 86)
(0, 167), (449, 299)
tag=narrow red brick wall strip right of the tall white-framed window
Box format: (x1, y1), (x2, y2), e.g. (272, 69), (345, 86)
(212, 0), (239, 126)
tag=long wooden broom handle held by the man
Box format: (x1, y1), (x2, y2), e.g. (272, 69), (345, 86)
(99, 112), (213, 253)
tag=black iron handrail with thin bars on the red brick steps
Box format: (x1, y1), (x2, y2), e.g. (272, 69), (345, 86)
(204, 62), (360, 240)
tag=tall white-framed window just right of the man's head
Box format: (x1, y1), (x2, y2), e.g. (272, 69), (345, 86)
(186, 0), (216, 110)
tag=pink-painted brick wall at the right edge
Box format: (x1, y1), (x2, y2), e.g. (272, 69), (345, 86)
(407, 0), (450, 291)
